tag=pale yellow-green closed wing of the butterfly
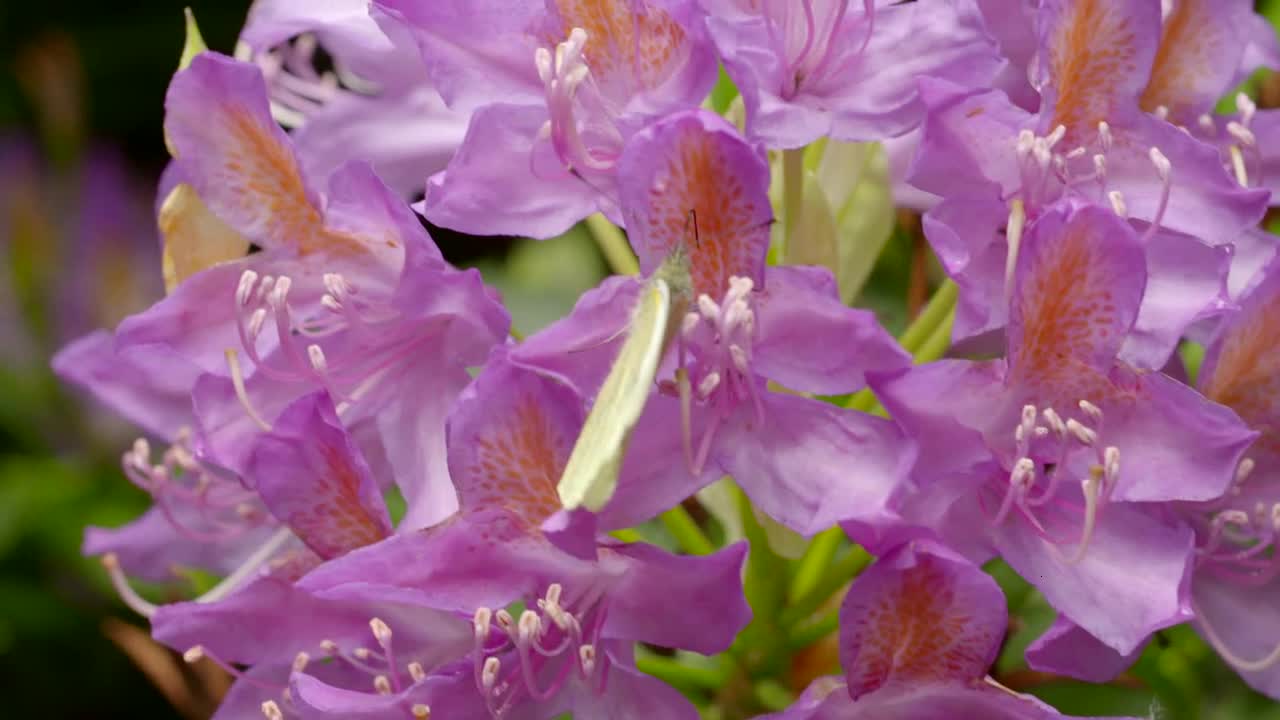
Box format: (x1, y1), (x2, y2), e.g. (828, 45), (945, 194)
(557, 278), (671, 512)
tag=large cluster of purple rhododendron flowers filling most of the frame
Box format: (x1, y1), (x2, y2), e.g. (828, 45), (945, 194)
(55, 0), (1280, 720)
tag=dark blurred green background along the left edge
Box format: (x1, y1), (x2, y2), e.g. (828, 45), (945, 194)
(0, 0), (262, 719)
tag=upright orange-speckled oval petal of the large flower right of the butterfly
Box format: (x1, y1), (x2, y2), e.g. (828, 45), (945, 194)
(1009, 206), (1146, 404)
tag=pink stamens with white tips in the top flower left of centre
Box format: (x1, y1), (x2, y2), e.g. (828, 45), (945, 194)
(534, 27), (622, 181)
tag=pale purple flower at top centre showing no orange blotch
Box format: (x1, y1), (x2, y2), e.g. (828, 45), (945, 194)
(703, 0), (1001, 149)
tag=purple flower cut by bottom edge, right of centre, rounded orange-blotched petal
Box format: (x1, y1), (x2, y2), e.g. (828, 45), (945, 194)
(765, 541), (1136, 720)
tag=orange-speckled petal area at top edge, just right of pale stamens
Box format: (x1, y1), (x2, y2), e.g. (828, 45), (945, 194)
(556, 0), (689, 99)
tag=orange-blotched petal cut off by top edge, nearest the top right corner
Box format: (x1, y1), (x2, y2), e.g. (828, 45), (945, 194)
(1142, 0), (1253, 118)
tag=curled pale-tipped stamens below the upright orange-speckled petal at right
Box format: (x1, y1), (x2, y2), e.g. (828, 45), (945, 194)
(988, 400), (1120, 564)
